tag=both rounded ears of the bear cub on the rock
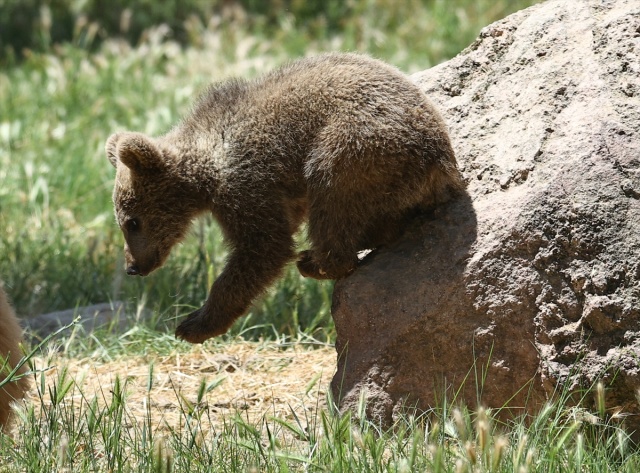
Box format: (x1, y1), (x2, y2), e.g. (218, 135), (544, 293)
(105, 132), (164, 174)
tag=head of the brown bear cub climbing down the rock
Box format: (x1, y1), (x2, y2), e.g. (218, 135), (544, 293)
(105, 132), (200, 276)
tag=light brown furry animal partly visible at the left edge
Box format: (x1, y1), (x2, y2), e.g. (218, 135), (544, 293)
(0, 286), (29, 430)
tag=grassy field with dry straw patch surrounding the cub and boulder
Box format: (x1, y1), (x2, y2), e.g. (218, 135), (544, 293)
(0, 0), (640, 472)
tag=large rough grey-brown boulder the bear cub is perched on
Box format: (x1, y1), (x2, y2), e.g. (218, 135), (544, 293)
(332, 0), (640, 428)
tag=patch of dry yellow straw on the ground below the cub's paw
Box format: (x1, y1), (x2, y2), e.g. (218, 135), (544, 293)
(28, 341), (336, 432)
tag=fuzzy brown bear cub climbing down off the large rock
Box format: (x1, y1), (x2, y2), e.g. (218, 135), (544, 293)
(106, 53), (463, 343)
